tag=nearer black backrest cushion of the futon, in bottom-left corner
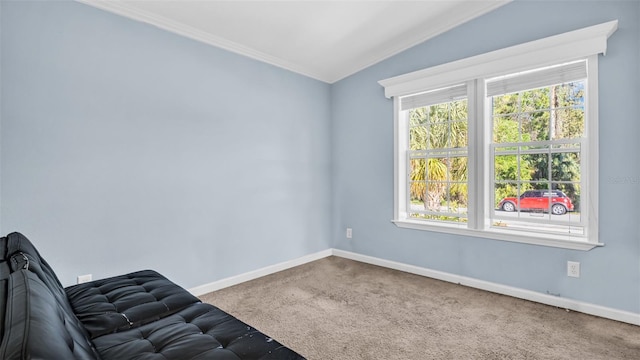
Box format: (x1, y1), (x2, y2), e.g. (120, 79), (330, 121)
(0, 270), (100, 360)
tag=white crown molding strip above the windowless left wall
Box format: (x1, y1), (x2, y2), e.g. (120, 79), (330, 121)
(75, 0), (329, 82)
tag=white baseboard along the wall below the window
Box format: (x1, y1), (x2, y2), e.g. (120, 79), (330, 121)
(333, 249), (640, 326)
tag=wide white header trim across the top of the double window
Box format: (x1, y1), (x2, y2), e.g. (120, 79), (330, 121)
(378, 20), (618, 98)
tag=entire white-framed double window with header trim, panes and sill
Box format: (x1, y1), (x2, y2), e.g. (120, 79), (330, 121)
(380, 21), (617, 250)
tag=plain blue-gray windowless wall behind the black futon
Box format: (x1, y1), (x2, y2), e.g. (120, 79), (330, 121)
(0, 1), (331, 287)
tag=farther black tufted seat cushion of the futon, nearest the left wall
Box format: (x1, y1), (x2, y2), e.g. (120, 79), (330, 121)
(65, 270), (200, 338)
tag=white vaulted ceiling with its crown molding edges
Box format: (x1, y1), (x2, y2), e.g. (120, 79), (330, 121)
(77, 0), (512, 83)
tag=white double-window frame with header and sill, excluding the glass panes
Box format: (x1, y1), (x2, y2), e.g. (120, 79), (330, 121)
(379, 20), (618, 250)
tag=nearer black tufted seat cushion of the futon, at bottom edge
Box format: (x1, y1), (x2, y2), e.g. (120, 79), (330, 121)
(93, 303), (304, 360)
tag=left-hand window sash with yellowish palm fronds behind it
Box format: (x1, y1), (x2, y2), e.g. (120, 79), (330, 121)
(402, 85), (469, 223)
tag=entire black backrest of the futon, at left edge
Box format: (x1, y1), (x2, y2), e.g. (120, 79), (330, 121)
(0, 233), (100, 360)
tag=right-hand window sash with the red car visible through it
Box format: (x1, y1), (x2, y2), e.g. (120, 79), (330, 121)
(487, 61), (586, 236)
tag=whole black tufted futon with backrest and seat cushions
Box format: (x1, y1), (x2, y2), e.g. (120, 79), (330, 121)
(0, 233), (304, 360)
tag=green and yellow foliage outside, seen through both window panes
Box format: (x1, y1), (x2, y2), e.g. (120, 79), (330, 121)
(409, 82), (585, 221)
